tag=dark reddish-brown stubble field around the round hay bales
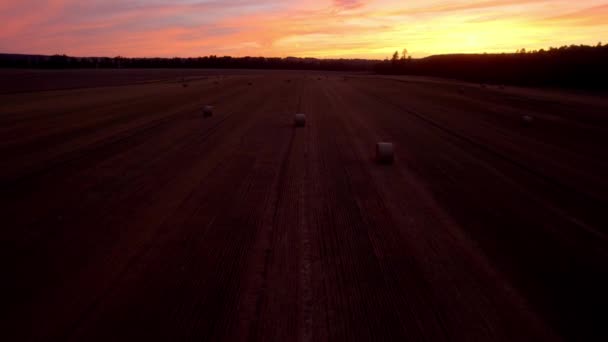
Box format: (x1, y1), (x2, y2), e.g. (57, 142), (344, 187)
(0, 71), (608, 341)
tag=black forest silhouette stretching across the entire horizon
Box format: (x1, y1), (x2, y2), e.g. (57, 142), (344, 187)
(0, 43), (608, 89)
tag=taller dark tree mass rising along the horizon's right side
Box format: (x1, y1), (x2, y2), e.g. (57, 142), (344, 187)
(374, 43), (608, 89)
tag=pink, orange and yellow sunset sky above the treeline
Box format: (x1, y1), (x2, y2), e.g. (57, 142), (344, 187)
(0, 0), (608, 58)
